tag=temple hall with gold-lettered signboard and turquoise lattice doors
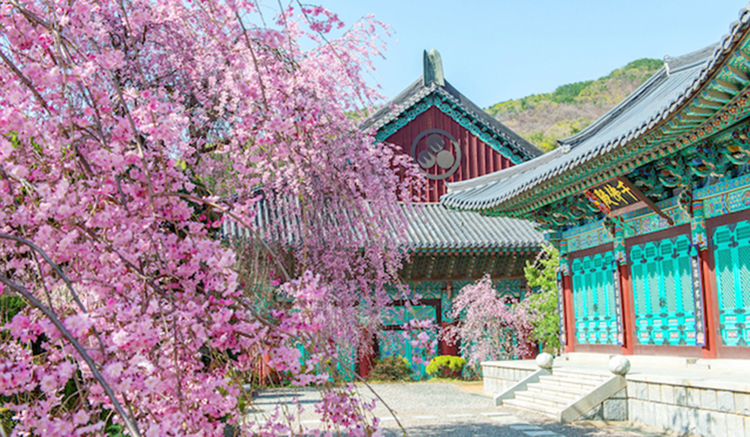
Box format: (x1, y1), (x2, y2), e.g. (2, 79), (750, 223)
(441, 10), (750, 358)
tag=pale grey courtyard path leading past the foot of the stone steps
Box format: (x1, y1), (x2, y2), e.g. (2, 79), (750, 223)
(250, 382), (660, 437)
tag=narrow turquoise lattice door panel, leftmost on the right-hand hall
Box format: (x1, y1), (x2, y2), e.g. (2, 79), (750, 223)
(571, 252), (619, 344)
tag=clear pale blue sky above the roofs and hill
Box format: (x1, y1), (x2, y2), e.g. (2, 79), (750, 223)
(284, 0), (747, 107)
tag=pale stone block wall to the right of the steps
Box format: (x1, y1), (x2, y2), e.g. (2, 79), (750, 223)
(627, 377), (750, 437)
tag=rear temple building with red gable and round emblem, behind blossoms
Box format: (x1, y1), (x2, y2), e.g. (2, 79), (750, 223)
(360, 50), (543, 375)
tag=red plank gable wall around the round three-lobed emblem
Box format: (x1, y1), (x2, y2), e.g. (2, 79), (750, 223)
(385, 106), (513, 202)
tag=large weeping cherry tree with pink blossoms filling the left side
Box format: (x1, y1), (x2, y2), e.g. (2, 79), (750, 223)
(0, 0), (417, 436)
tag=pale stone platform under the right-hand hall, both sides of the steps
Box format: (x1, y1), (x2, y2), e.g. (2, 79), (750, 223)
(482, 353), (750, 437)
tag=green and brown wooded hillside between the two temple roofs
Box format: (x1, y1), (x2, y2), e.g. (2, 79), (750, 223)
(487, 58), (663, 151)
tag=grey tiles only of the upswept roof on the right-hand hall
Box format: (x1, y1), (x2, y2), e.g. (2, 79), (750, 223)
(440, 9), (750, 211)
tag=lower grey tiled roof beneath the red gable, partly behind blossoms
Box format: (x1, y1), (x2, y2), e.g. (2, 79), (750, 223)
(222, 199), (544, 250)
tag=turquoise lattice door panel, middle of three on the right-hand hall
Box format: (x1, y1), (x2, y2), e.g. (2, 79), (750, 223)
(630, 235), (702, 346)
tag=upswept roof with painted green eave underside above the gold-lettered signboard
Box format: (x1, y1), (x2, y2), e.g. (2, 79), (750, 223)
(441, 8), (750, 216)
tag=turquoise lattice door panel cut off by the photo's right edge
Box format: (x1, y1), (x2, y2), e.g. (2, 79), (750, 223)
(713, 221), (750, 346)
